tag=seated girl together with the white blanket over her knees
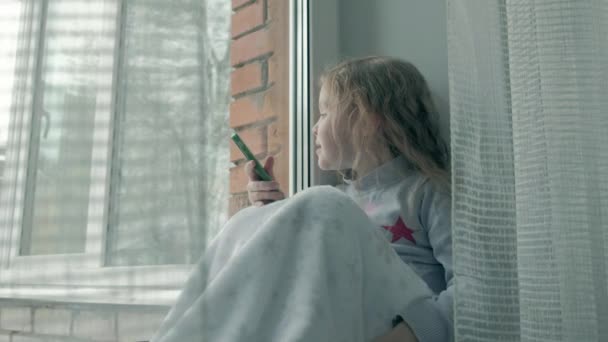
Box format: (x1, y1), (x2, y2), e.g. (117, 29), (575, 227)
(153, 57), (453, 342)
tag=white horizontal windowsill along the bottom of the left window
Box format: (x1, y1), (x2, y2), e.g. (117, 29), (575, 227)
(0, 265), (193, 306)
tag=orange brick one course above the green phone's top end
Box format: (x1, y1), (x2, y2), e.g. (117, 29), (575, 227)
(230, 90), (276, 128)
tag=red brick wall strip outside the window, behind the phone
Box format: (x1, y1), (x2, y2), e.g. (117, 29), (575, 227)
(229, 0), (289, 215)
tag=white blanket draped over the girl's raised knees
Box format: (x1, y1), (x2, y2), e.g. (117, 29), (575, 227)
(152, 186), (432, 342)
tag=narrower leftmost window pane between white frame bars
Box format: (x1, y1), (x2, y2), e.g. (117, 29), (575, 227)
(21, 0), (116, 255)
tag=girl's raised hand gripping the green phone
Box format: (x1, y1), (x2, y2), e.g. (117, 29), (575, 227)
(245, 157), (285, 207)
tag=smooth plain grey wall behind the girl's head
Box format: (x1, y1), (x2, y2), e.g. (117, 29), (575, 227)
(310, 0), (450, 185)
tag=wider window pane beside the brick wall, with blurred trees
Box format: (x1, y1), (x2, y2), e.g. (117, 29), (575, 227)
(106, 0), (231, 265)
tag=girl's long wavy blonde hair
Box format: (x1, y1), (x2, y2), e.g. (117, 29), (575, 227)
(320, 56), (450, 188)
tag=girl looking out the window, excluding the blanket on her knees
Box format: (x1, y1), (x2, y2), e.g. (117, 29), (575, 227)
(246, 57), (453, 340)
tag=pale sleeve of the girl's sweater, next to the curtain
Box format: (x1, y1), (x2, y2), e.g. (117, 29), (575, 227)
(402, 182), (454, 342)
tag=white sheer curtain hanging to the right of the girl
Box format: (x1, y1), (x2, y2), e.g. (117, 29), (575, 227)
(448, 0), (608, 341)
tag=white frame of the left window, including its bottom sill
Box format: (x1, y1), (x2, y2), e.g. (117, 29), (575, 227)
(0, 0), (192, 305)
